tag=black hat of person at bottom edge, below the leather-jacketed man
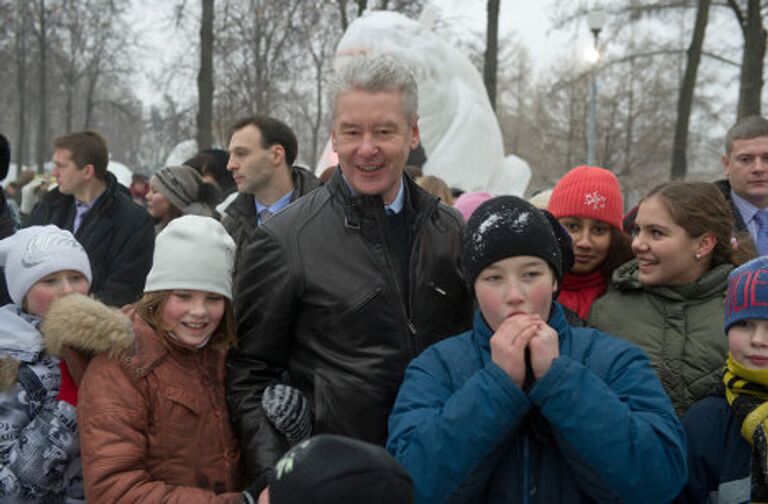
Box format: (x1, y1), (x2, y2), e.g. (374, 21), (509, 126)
(269, 434), (413, 504)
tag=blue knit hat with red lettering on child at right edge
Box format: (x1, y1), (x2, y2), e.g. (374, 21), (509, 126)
(723, 256), (768, 332)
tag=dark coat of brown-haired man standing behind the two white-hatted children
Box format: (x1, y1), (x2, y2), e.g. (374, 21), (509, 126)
(27, 172), (155, 307)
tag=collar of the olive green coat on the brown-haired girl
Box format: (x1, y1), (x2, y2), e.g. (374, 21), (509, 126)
(611, 259), (733, 301)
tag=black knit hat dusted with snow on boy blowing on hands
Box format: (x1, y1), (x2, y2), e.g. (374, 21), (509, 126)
(463, 196), (573, 287)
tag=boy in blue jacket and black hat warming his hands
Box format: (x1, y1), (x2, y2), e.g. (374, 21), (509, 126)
(387, 196), (687, 503)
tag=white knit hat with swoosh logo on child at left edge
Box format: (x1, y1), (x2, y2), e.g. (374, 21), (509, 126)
(0, 224), (91, 306)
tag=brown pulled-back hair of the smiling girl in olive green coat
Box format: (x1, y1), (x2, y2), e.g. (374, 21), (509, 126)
(640, 182), (737, 268)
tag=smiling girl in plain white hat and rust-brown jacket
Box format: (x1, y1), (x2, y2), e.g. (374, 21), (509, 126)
(78, 215), (249, 503)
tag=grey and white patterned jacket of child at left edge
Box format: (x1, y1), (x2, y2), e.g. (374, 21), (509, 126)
(0, 305), (84, 503)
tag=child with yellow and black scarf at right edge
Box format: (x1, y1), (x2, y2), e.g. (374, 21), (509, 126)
(678, 256), (768, 503)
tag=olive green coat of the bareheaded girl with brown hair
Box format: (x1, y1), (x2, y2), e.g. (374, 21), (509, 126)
(589, 260), (733, 415)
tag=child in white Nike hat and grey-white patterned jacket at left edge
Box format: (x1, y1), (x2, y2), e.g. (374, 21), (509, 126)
(0, 225), (132, 503)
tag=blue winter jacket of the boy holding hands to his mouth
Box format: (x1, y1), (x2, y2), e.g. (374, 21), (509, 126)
(387, 303), (687, 503)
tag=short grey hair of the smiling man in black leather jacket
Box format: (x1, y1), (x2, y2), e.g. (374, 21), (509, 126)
(329, 52), (419, 124)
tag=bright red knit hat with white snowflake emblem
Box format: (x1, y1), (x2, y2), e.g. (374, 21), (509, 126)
(547, 166), (624, 230)
